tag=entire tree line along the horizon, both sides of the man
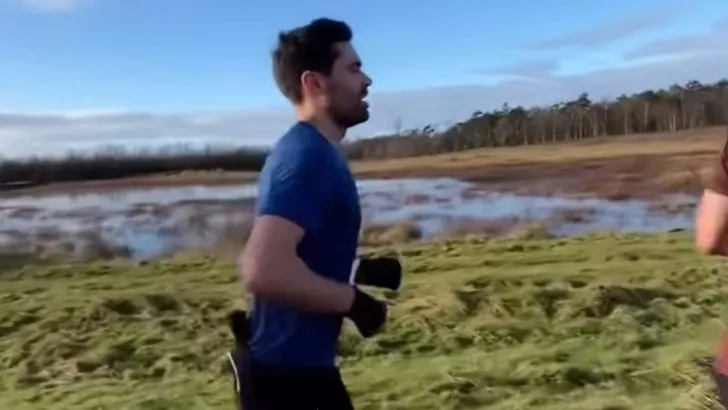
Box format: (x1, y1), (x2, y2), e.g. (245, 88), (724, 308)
(0, 80), (728, 185)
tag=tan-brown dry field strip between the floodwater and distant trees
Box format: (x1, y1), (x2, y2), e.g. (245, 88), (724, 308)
(5, 127), (726, 199)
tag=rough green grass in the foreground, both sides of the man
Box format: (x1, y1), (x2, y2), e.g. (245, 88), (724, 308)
(0, 233), (728, 410)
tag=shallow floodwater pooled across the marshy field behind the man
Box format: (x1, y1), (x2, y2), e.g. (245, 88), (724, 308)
(0, 178), (696, 258)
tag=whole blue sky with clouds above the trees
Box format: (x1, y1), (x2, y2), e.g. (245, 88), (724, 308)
(0, 0), (728, 158)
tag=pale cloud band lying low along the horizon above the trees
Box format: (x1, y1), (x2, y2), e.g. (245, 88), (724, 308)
(0, 50), (728, 160)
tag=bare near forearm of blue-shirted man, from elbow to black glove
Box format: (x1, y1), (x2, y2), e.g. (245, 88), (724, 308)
(246, 258), (354, 314)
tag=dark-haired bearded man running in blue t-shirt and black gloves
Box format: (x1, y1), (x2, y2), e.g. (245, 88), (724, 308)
(229, 19), (401, 410)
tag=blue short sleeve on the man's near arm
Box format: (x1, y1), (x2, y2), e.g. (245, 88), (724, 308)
(258, 149), (330, 232)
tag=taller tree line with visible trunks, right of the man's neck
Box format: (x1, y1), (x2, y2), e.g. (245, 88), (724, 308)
(347, 80), (728, 160)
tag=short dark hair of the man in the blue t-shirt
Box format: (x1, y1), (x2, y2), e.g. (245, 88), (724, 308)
(273, 18), (352, 104)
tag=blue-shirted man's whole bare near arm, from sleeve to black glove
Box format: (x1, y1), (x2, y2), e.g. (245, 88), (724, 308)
(239, 215), (355, 314)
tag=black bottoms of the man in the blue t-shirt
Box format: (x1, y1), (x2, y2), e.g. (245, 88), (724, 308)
(228, 346), (354, 410)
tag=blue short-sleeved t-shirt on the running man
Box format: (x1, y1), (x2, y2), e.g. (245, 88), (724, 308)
(250, 122), (361, 367)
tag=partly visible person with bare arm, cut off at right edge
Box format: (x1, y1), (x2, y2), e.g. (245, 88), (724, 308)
(695, 135), (728, 408)
